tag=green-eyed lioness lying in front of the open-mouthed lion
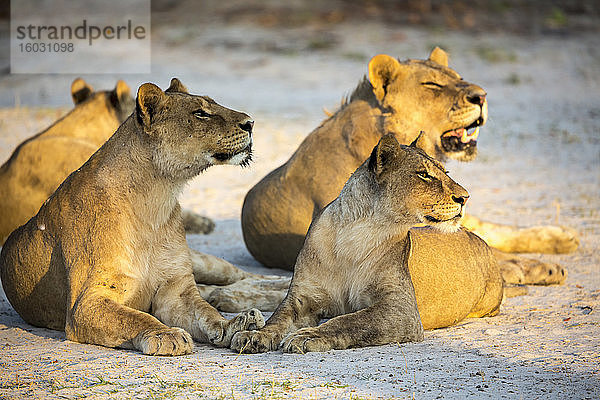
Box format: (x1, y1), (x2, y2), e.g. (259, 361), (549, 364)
(231, 135), (502, 353)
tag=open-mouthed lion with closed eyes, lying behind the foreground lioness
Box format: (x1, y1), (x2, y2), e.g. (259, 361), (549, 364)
(241, 48), (578, 283)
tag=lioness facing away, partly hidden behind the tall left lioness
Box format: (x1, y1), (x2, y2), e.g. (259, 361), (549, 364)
(0, 78), (214, 245)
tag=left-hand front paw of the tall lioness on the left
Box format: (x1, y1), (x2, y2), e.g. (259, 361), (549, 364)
(134, 328), (194, 356)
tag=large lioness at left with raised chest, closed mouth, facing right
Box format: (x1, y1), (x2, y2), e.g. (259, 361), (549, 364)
(0, 79), (264, 355)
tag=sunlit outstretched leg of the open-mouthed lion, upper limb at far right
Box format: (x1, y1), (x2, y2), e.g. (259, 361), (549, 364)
(462, 215), (579, 254)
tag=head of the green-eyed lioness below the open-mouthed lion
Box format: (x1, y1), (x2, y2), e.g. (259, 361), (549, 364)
(368, 134), (469, 232)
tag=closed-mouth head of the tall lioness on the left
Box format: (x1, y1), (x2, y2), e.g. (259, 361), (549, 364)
(135, 78), (254, 179)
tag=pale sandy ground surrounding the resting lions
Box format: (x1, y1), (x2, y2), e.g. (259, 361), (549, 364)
(0, 18), (600, 399)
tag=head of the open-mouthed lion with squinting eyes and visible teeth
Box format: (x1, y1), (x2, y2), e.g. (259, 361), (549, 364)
(369, 47), (487, 161)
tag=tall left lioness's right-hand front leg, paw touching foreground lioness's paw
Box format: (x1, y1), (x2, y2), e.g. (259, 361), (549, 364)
(152, 274), (265, 347)
